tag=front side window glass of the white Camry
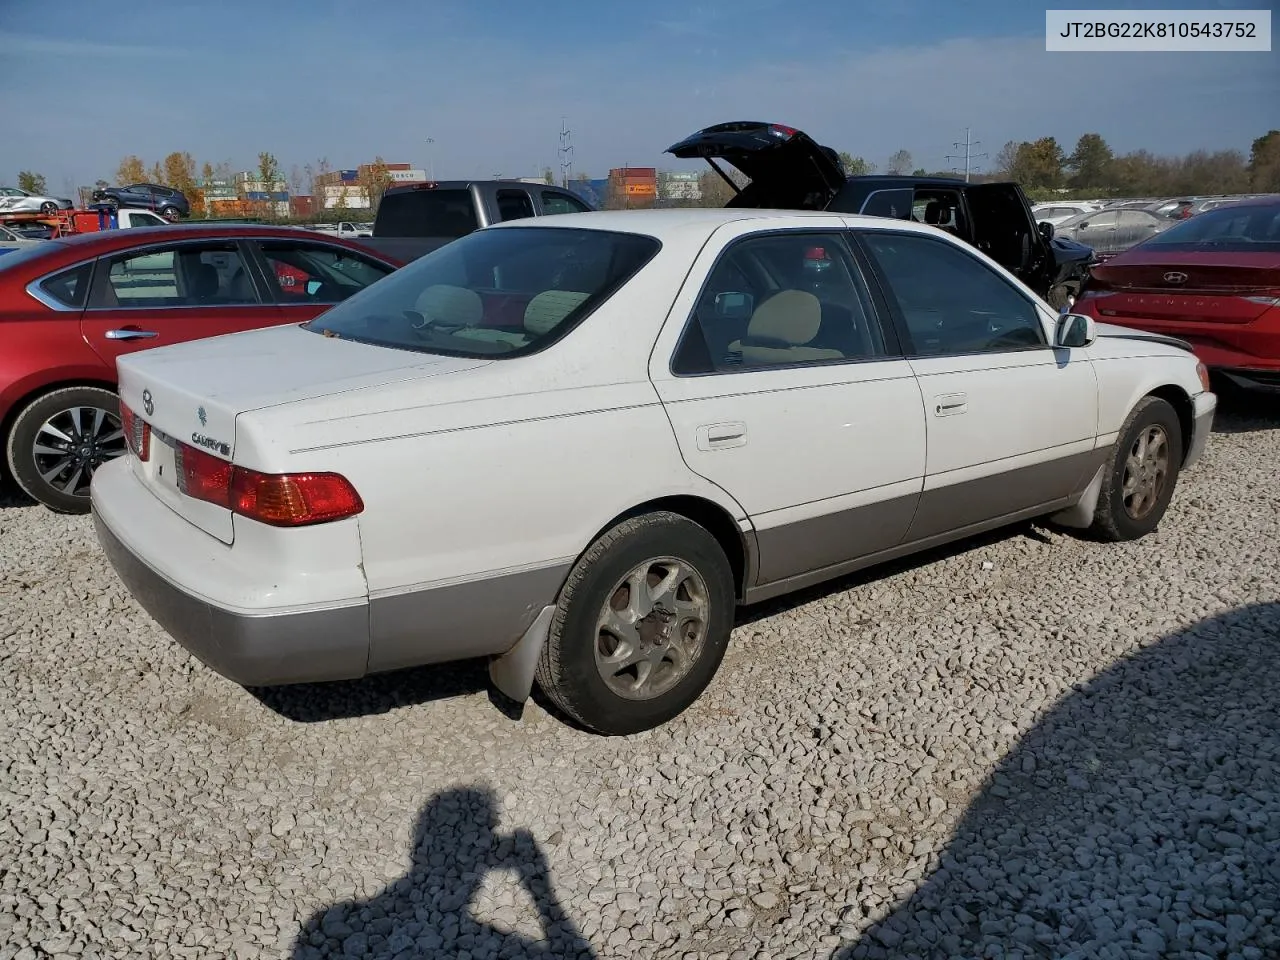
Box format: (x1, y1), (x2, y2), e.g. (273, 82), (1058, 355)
(861, 230), (1048, 357)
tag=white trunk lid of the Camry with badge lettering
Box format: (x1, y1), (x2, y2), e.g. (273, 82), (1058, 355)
(118, 325), (492, 544)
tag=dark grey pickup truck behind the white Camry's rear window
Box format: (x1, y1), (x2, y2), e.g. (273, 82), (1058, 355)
(360, 180), (591, 264)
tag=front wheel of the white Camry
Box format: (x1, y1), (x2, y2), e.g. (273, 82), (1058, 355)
(1093, 397), (1183, 543)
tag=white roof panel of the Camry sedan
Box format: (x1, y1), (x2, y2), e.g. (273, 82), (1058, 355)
(486, 207), (962, 241)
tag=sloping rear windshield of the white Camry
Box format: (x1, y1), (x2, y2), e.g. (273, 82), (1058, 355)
(303, 227), (659, 357)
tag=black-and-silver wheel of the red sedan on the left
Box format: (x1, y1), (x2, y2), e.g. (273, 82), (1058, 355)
(5, 387), (127, 513)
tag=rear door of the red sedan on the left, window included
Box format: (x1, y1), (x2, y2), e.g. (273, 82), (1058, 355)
(81, 239), (283, 369)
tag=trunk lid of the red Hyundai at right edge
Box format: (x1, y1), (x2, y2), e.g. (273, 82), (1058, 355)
(1085, 247), (1280, 324)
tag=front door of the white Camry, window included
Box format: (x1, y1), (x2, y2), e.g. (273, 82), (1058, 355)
(858, 230), (1098, 540)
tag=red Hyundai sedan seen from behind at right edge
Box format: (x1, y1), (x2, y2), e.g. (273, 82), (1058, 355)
(1074, 197), (1280, 389)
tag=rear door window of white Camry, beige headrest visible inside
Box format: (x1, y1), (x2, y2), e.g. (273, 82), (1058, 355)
(672, 233), (884, 376)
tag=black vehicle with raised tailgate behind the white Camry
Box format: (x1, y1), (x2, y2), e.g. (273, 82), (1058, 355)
(666, 120), (1093, 310)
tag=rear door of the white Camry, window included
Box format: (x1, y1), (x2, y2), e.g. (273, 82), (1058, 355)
(650, 218), (924, 585)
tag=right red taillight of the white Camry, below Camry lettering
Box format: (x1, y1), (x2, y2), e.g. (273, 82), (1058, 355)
(174, 443), (365, 526)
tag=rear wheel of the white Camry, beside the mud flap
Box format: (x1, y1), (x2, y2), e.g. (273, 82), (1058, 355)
(536, 511), (736, 735)
